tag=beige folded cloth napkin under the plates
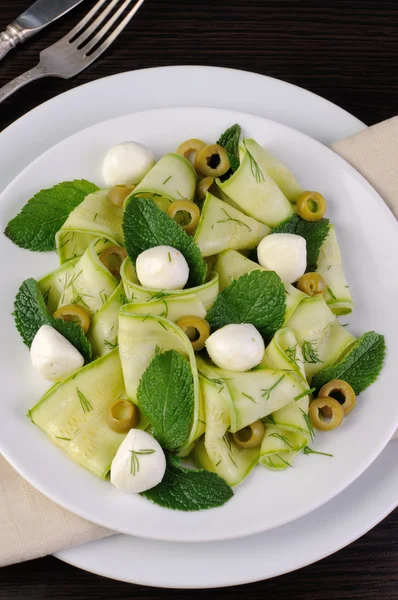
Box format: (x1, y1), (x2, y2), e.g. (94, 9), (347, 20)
(0, 117), (398, 566)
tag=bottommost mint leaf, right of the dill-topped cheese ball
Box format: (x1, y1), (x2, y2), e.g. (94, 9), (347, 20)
(142, 454), (234, 511)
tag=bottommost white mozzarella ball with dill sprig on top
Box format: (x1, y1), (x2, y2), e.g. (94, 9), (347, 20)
(111, 429), (166, 494)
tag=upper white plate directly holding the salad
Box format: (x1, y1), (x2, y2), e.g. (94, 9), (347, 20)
(0, 103), (398, 541)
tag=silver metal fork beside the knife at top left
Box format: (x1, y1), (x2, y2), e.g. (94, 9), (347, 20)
(0, 0), (144, 103)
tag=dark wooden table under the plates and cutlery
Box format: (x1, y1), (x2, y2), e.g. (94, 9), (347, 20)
(0, 0), (398, 600)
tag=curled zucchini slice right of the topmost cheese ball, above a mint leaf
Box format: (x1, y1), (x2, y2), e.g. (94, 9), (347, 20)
(131, 153), (196, 205)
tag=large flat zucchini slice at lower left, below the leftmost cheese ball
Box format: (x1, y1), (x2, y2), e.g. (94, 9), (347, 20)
(29, 349), (125, 478)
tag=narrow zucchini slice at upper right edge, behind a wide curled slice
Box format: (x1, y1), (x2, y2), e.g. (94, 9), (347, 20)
(241, 139), (304, 204)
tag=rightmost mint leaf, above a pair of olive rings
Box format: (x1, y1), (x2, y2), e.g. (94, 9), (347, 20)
(312, 331), (386, 394)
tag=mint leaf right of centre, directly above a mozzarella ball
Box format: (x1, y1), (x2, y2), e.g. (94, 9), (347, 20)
(206, 271), (286, 339)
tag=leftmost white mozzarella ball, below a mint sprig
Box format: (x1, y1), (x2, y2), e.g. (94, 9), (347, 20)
(30, 325), (84, 381)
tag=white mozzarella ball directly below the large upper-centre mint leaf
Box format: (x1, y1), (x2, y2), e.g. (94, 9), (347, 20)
(135, 246), (189, 290)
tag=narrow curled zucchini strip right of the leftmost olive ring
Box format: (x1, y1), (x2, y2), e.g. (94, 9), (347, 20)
(87, 283), (124, 358)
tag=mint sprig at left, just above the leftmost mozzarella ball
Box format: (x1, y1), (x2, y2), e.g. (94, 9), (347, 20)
(14, 278), (91, 362)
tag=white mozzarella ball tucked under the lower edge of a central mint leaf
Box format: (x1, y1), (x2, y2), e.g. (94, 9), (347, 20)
(206, 323), (265, 372)
